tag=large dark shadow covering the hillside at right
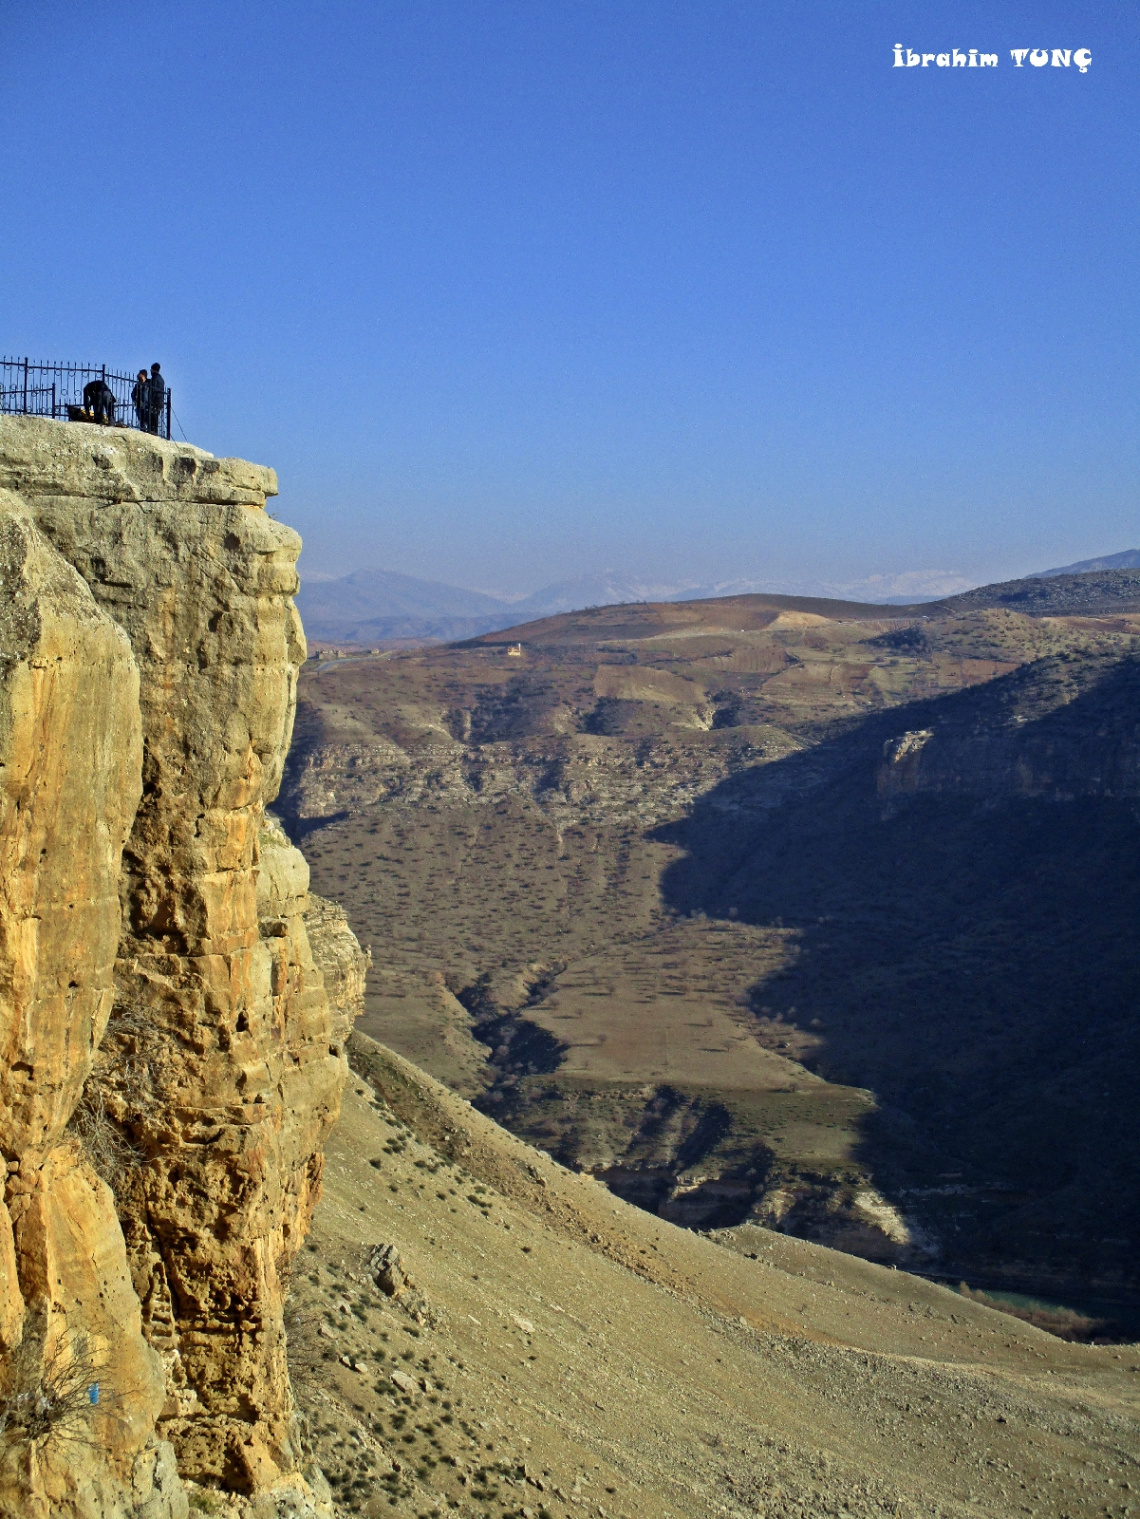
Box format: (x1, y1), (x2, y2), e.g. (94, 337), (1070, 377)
(654, 661), (1140, 1293)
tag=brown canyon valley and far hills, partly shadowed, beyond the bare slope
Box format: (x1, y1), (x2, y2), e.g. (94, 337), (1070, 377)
(278, 583), (1140, 1323)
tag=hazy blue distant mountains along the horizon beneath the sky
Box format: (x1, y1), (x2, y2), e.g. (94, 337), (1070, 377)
(296, 548), (1140, 646)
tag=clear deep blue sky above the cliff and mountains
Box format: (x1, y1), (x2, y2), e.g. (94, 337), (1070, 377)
(0, 0), (1140, 592)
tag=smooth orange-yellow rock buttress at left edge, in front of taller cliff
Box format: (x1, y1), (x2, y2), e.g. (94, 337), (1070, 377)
(0, 491), (170, 1516)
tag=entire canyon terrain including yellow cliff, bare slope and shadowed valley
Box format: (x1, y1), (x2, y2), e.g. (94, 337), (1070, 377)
(0, 416), (1140, 1519)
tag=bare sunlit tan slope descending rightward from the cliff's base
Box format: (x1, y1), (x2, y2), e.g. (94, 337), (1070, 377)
(290, 1036), (1140, 1519)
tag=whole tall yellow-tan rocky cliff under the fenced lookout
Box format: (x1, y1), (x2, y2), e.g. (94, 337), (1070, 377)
(0, 418), (362, 1519)
